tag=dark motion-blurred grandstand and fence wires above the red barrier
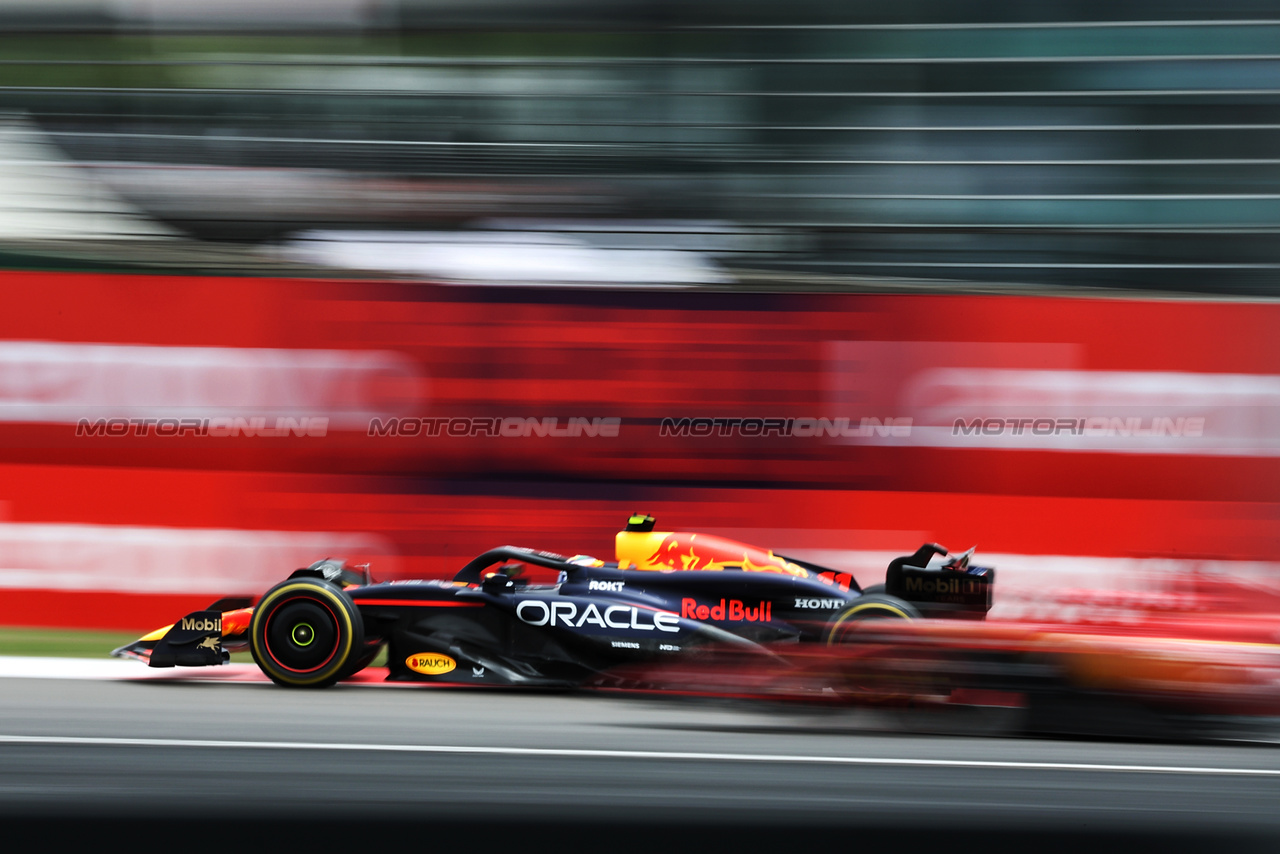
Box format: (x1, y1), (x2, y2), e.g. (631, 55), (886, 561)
(0, 0), (1280, 294)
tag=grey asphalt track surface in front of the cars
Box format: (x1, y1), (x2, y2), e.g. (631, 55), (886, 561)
(0, 668), (1280, 851)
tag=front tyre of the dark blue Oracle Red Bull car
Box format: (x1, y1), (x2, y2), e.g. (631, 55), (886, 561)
(250, 577), (365, 688)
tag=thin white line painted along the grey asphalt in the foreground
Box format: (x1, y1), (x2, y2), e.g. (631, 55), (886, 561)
(0, 735), (1280, 777)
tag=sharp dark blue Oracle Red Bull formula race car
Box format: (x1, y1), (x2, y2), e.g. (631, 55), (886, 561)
(113, 515), (995, 688)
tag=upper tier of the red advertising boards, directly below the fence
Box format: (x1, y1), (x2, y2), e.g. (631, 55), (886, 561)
(0, 273), (1280, 501)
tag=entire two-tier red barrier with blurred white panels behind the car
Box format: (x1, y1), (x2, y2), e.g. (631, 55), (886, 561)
(0, 273), (1280, 632)
